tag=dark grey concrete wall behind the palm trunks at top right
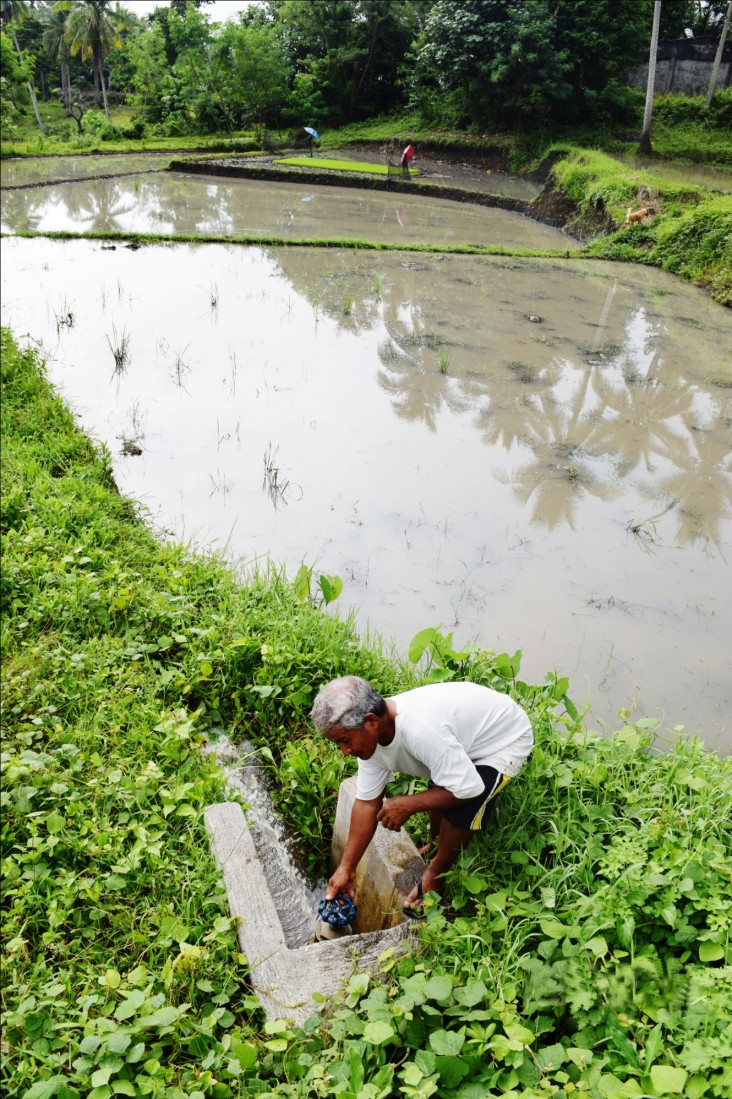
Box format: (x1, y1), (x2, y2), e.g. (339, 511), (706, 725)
(628, 36), (732, 96)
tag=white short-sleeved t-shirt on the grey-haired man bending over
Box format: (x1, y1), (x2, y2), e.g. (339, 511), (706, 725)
(356, 682), (534, 801)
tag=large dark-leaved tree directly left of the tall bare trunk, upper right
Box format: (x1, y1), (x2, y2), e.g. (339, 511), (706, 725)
(413, 0), (648, 126)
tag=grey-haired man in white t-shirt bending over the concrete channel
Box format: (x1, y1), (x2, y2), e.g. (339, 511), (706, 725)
(311, 676), (533, 915)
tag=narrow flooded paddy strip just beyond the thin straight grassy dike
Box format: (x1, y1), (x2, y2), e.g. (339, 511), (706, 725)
(1, 173), (578, 251)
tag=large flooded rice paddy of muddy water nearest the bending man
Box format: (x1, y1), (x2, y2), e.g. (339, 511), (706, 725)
(2, 240), (732, 750)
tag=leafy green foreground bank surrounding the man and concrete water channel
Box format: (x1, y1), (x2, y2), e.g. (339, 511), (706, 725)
(2, 332), (732, 1099)
